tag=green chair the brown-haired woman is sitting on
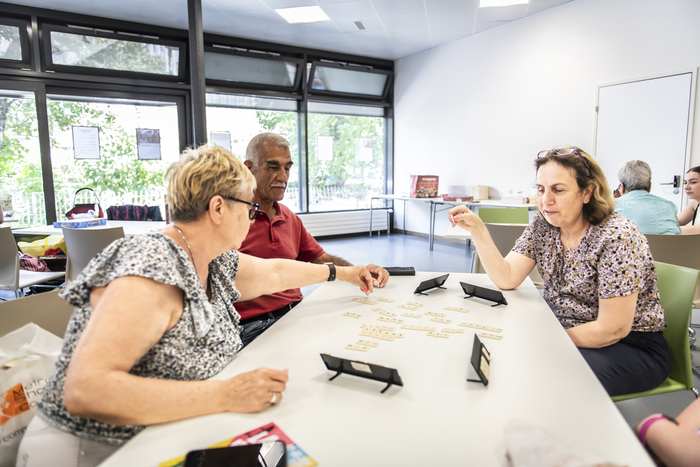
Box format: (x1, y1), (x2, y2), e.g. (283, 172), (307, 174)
(612, 261), (700, 402)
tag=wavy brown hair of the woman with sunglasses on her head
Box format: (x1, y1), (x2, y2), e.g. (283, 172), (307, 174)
(535, 146), (615, 225)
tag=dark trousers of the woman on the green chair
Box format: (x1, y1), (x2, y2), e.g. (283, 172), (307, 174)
(579, 332), (671, 396)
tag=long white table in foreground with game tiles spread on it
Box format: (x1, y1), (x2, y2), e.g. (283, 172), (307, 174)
(102, 272), (654, 467)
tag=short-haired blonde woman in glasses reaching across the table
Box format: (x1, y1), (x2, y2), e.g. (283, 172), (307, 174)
(17, 146), (374, 466)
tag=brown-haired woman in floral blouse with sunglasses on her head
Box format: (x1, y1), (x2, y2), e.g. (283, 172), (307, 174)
(449, 147), (671, 395)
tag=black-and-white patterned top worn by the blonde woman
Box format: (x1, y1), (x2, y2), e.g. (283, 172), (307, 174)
(39, 233), (242, 445)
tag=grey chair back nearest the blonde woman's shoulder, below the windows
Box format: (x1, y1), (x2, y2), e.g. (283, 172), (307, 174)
(63, 227), (124, 282)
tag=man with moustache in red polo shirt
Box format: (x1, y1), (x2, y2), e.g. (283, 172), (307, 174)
(236, 133), (389, 346)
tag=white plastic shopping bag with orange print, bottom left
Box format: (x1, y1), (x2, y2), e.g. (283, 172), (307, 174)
(0, 323), (63, 467)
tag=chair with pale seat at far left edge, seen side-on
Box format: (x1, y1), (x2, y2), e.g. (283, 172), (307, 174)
(0, 227), (66, 298)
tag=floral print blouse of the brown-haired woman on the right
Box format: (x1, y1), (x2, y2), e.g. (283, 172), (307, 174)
(513, 213), (666, 332)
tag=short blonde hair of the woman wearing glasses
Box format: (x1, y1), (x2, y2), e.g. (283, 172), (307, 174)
(167, 145), (256, 222)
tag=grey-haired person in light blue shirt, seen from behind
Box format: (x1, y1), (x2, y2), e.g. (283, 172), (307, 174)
(615, 161), (681, 235)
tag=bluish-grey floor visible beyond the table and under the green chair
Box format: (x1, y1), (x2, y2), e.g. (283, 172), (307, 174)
(0, 234), (700, 426)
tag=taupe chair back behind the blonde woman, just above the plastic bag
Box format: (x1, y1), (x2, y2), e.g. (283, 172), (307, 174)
(0, 290), (73, 337)
